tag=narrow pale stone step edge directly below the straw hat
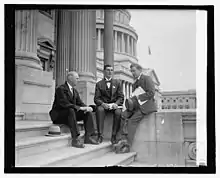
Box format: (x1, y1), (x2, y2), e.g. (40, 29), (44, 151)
(15, 130), (85, 150)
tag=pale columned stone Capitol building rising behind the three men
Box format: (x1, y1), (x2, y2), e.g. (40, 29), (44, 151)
(15, 9), (161, 117)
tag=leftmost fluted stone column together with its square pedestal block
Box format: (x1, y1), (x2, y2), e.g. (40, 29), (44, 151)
(15, 10), (53, 120)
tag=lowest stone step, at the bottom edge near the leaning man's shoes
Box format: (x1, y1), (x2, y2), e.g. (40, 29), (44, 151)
(77, 152), (136, 167)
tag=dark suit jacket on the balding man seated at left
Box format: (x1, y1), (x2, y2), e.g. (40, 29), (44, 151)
(49, 82), (86, 121)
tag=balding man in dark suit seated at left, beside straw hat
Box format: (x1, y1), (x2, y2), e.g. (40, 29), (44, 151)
(49, 71), (98, 148)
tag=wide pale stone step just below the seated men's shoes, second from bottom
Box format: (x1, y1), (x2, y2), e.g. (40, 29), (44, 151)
(16, 142), (111, 167)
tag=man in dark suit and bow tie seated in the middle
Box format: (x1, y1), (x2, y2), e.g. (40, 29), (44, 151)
(94, 65), (124, 144)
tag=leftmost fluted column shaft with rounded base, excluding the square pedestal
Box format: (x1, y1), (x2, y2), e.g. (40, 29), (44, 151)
(15, 10), (42, 70)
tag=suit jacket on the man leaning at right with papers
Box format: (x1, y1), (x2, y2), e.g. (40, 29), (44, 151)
(132, 74), (157, 114)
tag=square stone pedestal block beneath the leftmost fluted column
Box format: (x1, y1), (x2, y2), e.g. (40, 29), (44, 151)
(15, 65), (55, 120)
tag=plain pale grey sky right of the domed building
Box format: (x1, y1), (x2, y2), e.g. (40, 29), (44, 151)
(129, 10), (196, 91)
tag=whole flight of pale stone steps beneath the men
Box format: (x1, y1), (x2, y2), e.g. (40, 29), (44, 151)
(15, 120), (136, 167)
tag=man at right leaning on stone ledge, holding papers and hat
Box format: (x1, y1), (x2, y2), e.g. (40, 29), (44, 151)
(121, 64), (157, 145)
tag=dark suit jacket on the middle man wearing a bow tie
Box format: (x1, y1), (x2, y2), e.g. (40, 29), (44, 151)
(94, 79), (124, 106)
